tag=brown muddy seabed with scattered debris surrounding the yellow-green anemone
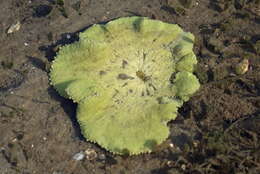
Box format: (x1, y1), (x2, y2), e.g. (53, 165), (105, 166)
(0, 0), (260, 174)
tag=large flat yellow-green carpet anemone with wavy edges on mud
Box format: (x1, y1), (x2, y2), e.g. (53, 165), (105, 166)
(50, 17), (199, 155)
